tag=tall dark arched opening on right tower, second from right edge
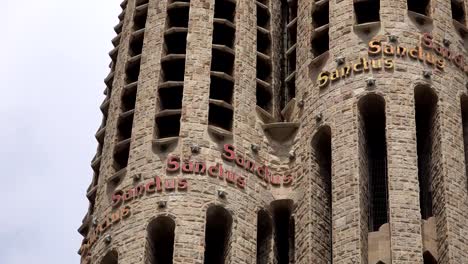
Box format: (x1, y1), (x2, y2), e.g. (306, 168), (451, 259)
(414, 86), (438, 219)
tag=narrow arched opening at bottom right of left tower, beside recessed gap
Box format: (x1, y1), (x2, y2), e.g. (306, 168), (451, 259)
(257, 210), (273, 264)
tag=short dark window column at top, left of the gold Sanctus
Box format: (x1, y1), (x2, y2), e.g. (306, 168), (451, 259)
(312, 1), (330, 57)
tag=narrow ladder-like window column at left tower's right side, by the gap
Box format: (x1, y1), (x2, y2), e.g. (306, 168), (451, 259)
(256, 0), (273, 113)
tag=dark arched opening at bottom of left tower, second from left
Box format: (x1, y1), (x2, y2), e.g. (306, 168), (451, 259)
(146, 216), (175, 264)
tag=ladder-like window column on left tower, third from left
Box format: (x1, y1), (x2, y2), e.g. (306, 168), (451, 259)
(208, 0), (236, 138)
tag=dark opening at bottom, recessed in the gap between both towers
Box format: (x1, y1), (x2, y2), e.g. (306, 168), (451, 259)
(271, 200), (295, 264)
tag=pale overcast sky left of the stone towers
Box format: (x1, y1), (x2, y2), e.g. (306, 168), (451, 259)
(0, 0), (121, 264)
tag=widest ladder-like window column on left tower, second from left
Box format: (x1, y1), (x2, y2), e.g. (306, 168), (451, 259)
(154, 0), (190, 148)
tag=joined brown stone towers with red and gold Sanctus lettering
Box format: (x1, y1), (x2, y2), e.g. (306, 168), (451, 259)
(79, 0), (468, 264)
